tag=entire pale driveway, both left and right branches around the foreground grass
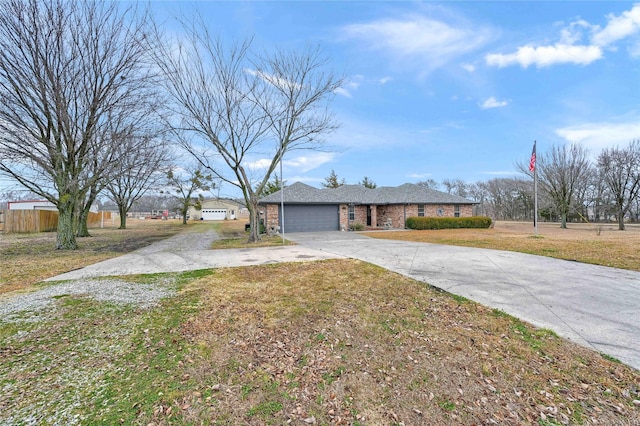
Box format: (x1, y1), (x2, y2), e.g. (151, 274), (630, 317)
(49, 228), (640, 370)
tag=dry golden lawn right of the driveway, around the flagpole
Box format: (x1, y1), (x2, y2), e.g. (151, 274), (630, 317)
(367, 222), (640, 271)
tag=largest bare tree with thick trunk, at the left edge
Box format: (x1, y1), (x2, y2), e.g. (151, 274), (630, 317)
(0, 0), (153, 249)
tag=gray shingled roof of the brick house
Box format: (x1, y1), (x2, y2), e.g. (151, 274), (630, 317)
(260, 182), (474, 205)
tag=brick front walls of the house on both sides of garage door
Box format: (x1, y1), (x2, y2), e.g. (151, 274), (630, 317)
(263, 204), (473, 231)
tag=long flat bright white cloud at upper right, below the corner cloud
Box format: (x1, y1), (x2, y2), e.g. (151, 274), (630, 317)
(485, 43), (602, 68)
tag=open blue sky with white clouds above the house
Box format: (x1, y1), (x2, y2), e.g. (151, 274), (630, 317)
(164, 1), (640, 192)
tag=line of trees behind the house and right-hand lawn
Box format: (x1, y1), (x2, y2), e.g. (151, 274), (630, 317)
(302, 140), (640, 230)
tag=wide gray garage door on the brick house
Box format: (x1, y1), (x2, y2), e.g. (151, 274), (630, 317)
(278, 204), (340, 233)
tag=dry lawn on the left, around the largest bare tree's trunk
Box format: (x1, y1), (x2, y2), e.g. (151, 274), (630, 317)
(0, 219), (184, 294)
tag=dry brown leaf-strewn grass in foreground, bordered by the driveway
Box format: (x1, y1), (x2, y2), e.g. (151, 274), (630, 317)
(171, 260), (640, 425)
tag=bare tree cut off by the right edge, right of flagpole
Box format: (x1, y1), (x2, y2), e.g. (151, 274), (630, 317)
(598, 140), (640, 231)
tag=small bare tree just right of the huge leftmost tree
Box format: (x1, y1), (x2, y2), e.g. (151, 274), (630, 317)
(106, 135), (170, 229)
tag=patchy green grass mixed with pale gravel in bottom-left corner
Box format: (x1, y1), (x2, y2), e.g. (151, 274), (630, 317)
(0, 271), (202, 424)
